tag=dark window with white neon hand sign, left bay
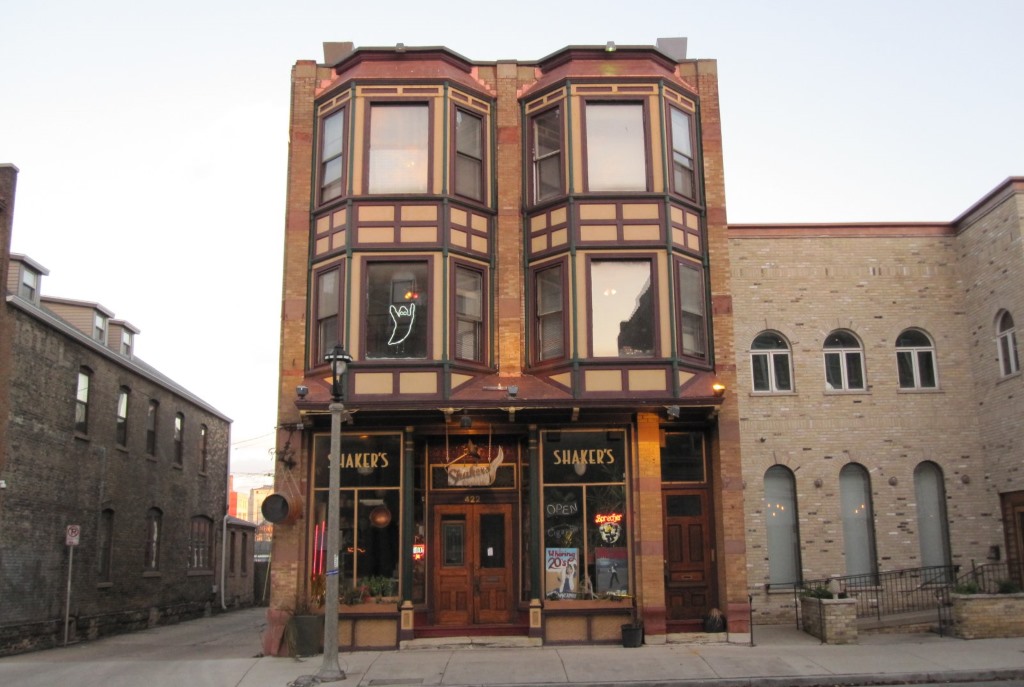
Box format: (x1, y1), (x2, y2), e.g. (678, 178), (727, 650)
(366, 262), (429, 358)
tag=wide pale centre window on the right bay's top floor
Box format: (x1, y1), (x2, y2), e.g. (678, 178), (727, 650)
(586, 102), (647, 191)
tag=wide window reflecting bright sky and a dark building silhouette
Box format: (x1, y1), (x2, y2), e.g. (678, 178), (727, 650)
(590, 260), (654, 357)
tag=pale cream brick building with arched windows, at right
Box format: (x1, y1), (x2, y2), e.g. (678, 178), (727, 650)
(729, 177), (1024, 621)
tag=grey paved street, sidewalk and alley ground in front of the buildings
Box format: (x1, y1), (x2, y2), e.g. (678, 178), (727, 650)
(0, 608), (1024, 687)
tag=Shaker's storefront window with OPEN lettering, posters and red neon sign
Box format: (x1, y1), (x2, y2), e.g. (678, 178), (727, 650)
(542, 430), (630, 599)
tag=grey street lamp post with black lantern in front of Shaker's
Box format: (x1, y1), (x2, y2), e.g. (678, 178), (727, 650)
(316, 343), (352, 682)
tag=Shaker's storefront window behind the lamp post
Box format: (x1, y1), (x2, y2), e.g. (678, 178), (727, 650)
(310, 434), (401, 595)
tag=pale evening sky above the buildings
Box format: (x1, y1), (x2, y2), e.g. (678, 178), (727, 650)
(0, 0), (1024, 489)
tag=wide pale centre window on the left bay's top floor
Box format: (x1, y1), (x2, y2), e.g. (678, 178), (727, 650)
(369, 103), (429, 194)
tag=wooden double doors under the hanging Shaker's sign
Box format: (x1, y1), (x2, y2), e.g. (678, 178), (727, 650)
(434, 504), (513, 625)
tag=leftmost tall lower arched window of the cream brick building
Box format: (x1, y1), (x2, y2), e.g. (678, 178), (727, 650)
(765, 465), (802, 586)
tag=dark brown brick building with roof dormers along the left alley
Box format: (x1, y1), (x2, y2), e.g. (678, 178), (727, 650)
(0, 166), (237, 653)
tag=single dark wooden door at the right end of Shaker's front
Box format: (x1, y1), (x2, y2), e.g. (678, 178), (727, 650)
(663, 489), (715, 620)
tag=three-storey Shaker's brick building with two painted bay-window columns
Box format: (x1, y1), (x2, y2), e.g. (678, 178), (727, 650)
(265, 39), (749, 652)
